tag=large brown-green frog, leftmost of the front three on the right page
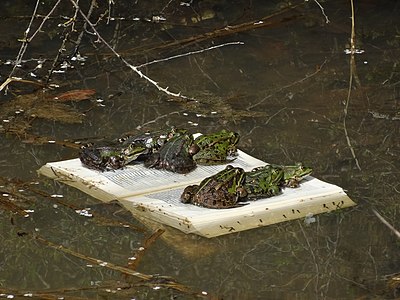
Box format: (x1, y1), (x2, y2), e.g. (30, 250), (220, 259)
(181, 165), (247, 209)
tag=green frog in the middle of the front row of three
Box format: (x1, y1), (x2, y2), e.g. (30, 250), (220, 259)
(244, 164), (284, 200)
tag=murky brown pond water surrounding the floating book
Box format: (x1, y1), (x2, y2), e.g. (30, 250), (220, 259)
(0, 0), (400, 299)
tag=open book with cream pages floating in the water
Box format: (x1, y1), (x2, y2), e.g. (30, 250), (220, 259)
(39, 150), (355, 238)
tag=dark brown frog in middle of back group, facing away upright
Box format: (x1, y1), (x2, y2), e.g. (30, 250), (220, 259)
(144, 133), (197, 174)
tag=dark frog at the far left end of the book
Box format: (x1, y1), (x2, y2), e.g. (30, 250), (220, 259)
(79, 144), (126, 172)
